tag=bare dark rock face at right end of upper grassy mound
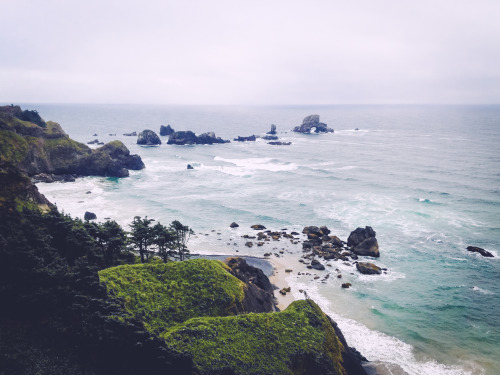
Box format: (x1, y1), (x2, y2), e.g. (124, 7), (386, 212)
(224, 257), (276, 312)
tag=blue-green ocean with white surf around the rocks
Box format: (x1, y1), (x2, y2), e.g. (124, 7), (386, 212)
(28, 104), (500, 374)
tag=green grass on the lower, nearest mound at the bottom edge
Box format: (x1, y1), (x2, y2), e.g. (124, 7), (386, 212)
(163, 300), (344, 375)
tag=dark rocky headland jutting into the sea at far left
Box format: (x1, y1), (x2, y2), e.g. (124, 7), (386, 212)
(0, 106), (144, 210)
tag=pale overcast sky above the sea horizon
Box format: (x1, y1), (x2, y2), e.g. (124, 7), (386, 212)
(0, 0), (500, 105)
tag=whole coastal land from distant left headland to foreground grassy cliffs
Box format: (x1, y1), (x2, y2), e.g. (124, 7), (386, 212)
(0, 106), (365, 375)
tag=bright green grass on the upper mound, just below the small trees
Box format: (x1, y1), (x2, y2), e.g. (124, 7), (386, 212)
(99, 259), (245, 334)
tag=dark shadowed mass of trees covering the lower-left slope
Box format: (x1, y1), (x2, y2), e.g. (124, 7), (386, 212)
(0, 208), (191, 375)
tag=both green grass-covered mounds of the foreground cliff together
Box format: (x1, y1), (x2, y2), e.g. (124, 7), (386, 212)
(99, 259), (344, 374)
